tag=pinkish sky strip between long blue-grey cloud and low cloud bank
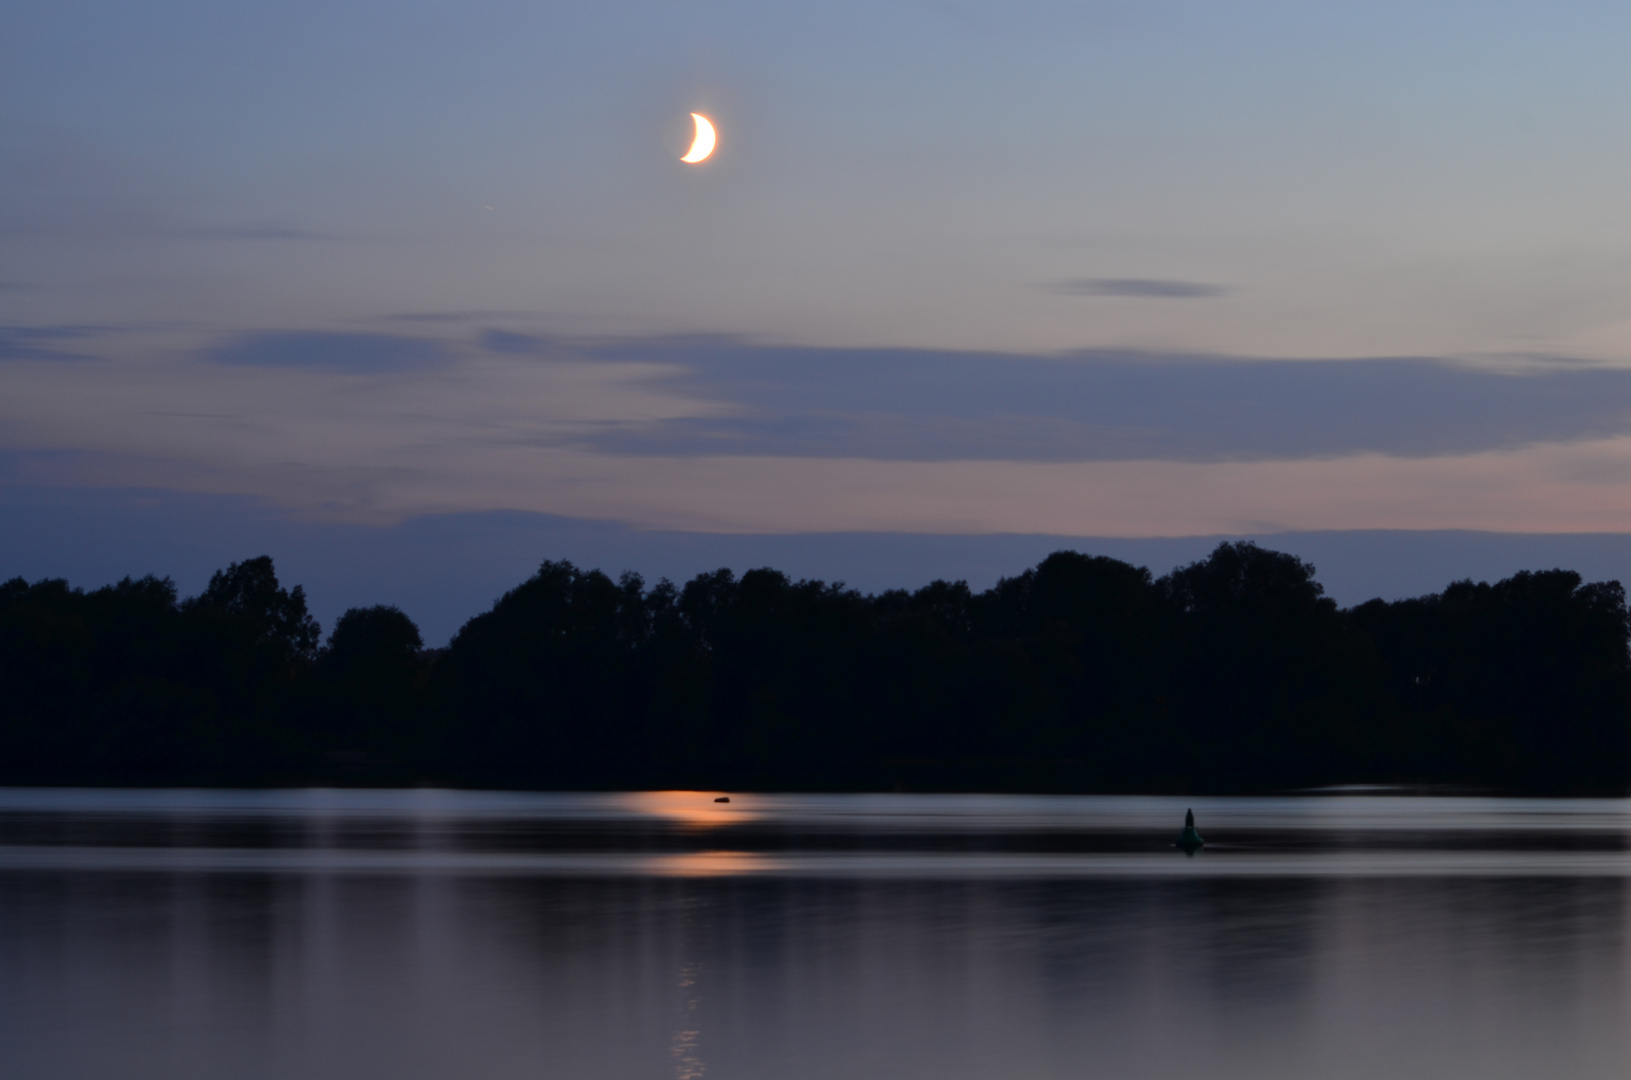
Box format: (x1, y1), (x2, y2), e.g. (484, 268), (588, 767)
(19, 439), (1631, 537)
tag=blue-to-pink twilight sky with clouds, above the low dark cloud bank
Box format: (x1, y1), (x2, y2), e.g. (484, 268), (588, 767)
(0, 0), (1631, 636)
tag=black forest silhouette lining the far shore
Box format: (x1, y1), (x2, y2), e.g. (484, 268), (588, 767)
(0, 542), (1631, 791)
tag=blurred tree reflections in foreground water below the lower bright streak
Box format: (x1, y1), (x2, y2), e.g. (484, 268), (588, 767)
(9, 873), (1631, 1080)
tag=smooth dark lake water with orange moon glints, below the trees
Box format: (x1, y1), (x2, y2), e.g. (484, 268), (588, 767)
(0, 790), (1631, 1080)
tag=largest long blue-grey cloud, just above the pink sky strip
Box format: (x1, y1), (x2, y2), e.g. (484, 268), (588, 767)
(538, 338), (1631, 462)
